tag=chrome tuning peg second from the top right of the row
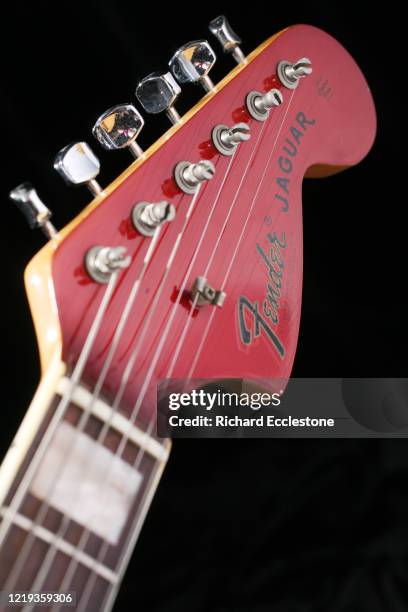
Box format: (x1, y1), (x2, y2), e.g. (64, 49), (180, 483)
(169, 40), (217, 92)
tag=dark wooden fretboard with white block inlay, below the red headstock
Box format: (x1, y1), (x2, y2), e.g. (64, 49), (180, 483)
(0, 379), (169, 611)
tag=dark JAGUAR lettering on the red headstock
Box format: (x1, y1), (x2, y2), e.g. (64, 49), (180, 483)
(275, 112), (316, 212)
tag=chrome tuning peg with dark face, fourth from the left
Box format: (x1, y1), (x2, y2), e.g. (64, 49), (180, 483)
(136, 72), (181, 123)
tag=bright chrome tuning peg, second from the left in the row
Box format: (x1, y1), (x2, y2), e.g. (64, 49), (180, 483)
(54, 142), (103, 196)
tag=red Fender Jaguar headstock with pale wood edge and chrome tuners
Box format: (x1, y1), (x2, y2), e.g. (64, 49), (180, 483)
(12, 20), (376, 420)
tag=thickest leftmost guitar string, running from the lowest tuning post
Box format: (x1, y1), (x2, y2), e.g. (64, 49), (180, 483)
(0, 272), (118, 546)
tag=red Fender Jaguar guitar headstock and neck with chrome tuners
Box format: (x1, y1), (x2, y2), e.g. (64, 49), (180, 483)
(0, 17), (376, 612)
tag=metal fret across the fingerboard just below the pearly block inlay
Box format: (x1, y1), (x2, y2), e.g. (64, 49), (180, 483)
(0, 506), (119, 584)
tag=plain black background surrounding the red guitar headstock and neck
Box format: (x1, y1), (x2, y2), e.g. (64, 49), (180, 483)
(0, 0), (408, 612)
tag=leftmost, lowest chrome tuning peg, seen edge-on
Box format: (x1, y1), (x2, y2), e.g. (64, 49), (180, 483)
(9, 183), (57, 238)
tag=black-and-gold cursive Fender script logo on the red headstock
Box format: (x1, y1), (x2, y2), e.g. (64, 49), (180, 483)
(238, 232), (286, 359)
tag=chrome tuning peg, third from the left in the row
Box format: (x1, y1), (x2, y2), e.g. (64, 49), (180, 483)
(92, 104), (144, 158)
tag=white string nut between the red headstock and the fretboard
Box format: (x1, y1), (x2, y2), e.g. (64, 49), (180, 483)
(57, 377), (169, 461)
